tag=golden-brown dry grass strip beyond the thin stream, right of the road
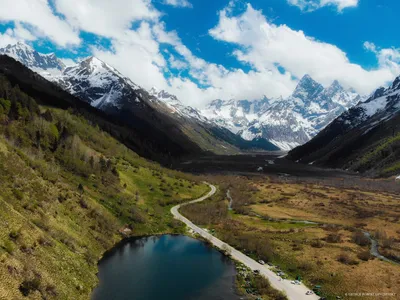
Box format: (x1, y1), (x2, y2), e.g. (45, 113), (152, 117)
(251, 183), (400, 236)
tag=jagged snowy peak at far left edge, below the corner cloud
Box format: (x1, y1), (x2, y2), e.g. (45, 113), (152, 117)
(0, 42), (65, 78)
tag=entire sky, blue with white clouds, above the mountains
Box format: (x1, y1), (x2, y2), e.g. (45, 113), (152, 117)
(0, 0), (400, 106)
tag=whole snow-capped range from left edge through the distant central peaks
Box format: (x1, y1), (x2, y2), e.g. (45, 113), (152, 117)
(0, 43), (363, 153)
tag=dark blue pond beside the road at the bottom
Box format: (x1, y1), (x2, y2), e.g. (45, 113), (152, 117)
(92, 235), (239, 300)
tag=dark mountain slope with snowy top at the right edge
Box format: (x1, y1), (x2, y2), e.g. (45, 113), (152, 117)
(289, 73), (400, 175)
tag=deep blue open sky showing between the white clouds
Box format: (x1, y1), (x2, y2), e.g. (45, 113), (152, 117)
(155, 0), (400, 68)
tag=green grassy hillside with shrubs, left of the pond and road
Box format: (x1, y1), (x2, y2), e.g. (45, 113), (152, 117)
(0, 107), (208, 299)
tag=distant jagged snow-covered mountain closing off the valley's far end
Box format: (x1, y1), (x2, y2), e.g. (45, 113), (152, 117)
(203, 75), (362, 150)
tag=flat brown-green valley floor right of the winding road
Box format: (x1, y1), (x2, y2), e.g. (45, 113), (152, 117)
(181, 171), (400, 299)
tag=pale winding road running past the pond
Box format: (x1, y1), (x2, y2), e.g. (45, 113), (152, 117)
(171, 183), (319, 300)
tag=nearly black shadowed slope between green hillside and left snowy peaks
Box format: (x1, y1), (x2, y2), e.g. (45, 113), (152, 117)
(0, 55), (206, 163)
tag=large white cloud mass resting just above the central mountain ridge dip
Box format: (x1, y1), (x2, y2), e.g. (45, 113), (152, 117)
(92, 18), (295, 107)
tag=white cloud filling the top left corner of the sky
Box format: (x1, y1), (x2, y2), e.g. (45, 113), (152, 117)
(0, 0), (80, 46)
